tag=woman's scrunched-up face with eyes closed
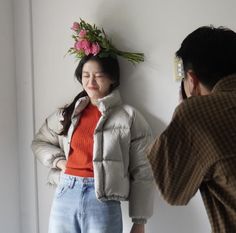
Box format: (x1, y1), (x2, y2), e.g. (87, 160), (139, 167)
(82, 60), (113, 100)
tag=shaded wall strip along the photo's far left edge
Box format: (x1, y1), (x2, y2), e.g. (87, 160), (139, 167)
(0, 0), (19, 233)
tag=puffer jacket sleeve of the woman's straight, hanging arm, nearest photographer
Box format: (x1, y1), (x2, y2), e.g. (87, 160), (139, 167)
(129, 111), (155, 223)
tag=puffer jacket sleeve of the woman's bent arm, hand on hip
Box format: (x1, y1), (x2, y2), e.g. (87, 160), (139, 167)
(31, 110), (65, 168)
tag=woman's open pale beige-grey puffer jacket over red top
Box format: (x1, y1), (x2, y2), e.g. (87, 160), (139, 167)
(32, 90), (154, 222)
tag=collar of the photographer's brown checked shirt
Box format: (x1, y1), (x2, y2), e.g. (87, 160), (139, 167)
(212, 74), (236, 93)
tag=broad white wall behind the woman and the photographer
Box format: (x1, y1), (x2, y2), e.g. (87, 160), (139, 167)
(15, 0), (236, 233)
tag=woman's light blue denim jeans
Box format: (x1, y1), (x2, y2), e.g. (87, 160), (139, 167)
(48, 174), (122, 233)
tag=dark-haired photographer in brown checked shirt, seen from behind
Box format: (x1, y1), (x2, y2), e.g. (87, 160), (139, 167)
(148, 26), (236, 233)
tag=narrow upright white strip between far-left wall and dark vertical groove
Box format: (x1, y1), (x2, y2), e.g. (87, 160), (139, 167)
(14, 0), (38, 233)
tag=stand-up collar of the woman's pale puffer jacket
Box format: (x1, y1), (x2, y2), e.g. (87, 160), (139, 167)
(71, 90), (122, 118)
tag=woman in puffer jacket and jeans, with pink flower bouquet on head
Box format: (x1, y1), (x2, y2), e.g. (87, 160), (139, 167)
(32, 20), (155, 233)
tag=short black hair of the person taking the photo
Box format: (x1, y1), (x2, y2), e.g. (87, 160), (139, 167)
(176, 26), (236, 89)
